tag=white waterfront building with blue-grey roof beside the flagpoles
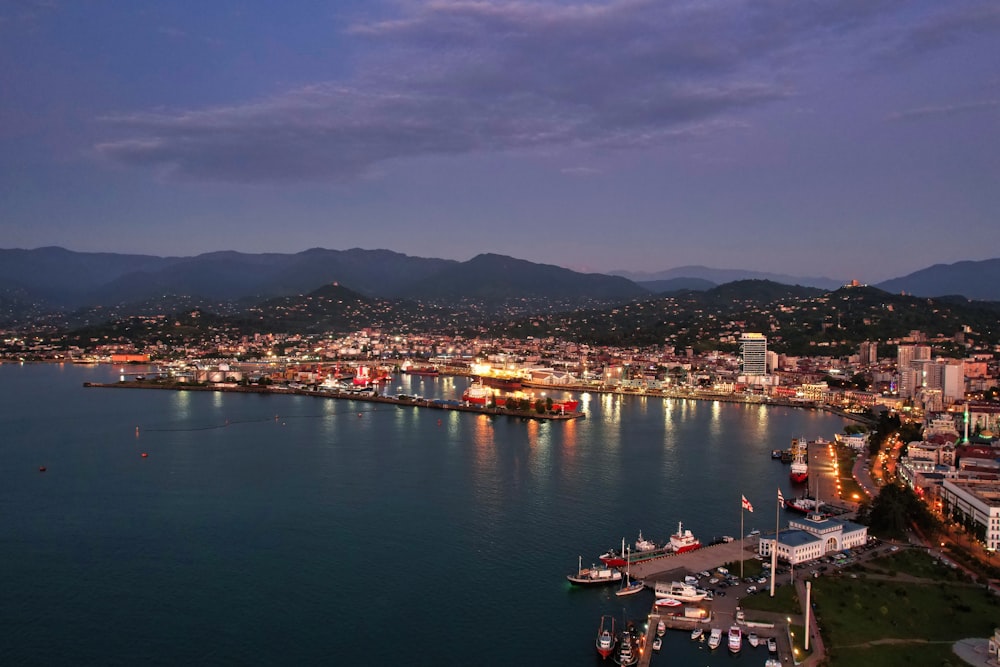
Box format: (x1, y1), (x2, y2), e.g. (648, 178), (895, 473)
(758, 515), (868, 565)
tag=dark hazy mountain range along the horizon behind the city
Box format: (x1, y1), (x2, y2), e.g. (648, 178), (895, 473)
(0, 247), (1000, 324)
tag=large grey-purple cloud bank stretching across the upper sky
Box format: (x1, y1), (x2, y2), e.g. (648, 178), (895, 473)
(95, 0), (956, 183)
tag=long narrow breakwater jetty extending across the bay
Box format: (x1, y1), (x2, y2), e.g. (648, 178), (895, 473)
(83, 380), (586, 421)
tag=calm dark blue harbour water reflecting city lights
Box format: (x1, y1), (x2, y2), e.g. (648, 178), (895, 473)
(0, 365), (843, 666)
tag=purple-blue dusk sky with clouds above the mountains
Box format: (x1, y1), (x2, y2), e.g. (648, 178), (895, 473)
(0, 0), (1000, 282)
